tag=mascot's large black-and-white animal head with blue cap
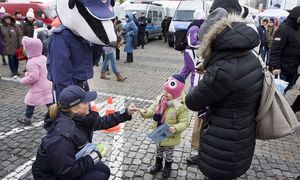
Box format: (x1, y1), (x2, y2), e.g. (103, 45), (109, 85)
(56, 0), (116, 45)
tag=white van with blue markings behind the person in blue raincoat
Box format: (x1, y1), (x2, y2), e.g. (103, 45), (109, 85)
(119, 3), (165, 43)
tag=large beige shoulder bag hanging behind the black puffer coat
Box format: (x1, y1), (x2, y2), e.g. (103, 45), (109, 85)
(255, 51), (300, 140)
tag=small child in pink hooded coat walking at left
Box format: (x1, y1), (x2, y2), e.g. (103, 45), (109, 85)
(18, 36), (53, 125)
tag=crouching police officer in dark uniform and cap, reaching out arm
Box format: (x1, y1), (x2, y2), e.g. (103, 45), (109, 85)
(32, 85), (136, 180)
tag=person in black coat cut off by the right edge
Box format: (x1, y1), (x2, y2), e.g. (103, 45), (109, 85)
(269, 6), (300, 92)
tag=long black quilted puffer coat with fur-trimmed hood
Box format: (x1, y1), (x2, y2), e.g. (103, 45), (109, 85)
(186, 15), (263, 180)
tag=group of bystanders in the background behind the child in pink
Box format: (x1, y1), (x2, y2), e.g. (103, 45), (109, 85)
(0, 7), (51, 77)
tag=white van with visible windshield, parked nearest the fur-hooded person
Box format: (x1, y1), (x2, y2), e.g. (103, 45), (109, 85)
(168, 0), (205, 47)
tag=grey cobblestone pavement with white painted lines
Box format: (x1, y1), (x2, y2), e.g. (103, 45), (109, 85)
(0, 41), (300, 180)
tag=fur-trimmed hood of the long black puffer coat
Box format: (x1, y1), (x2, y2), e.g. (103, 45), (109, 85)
(200, 14), (260, 64)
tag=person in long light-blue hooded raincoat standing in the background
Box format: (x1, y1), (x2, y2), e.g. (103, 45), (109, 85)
(124, 13), (138, 63)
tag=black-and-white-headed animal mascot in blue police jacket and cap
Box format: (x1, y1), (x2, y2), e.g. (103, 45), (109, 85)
(47, 0), (116, 100)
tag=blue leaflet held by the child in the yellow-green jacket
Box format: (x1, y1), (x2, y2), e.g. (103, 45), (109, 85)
(148, 123), (171, 144)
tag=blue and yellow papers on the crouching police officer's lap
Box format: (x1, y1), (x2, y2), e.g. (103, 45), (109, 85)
(75, 143), (109, 160)
